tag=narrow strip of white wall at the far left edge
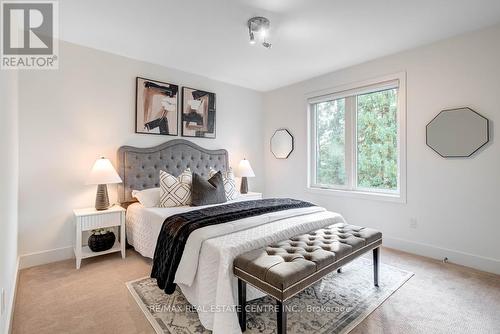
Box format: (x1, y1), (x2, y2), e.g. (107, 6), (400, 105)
(0, 71), (19, 333)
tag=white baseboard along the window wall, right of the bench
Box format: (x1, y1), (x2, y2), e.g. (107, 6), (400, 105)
(383, 236), (500, 275)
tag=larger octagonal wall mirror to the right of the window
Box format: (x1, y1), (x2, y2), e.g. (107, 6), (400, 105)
(426, 108), (490, 158)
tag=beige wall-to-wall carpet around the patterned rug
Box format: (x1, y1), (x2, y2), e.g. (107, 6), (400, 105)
(13, 249), (500, 334)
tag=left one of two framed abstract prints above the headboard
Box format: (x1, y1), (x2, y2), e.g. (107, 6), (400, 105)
(135, 77), (179, 136)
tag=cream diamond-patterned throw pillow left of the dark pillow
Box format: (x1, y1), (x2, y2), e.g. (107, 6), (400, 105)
(160, 168), (193, 208)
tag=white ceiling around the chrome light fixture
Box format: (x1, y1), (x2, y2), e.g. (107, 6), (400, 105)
(60, 0), (500, 91)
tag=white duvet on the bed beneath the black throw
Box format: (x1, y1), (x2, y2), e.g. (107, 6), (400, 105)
(126, 203), (344, 334)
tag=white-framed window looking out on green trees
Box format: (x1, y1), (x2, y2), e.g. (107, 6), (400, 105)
(308, 75), (405, 200)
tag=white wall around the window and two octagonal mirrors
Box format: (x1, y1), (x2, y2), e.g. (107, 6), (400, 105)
(264, 26), (500, 273)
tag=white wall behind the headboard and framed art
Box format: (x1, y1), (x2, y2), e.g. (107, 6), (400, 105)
(19, 42), (264, 266)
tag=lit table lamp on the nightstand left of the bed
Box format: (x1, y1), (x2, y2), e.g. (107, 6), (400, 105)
(87, 157), (122, 210)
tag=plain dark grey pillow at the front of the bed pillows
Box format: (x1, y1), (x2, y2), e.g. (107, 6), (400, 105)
(191, 172), (227, 206)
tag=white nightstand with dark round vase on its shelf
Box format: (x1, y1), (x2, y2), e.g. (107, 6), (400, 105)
(73, 205), (125, 269)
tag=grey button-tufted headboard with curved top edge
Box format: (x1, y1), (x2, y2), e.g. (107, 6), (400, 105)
(117, 139), (229, 204)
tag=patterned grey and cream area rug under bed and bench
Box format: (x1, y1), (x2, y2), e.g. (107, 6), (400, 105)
(127, 258), (413, 334)
